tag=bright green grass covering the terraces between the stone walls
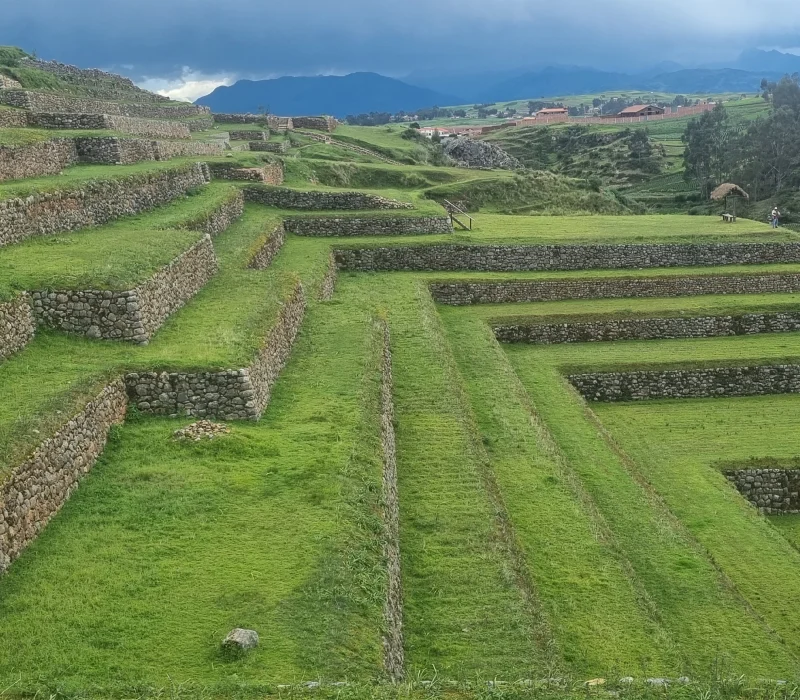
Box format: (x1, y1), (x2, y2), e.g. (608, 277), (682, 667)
(0, 71), (800, 700)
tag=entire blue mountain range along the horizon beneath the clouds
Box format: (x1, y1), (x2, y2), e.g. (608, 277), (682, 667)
(197, 50), (800, 118)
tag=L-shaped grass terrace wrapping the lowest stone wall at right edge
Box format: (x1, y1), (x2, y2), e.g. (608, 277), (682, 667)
(592, 395), (800, 655)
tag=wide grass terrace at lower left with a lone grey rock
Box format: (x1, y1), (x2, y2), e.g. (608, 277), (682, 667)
(0, 253), (385, 694)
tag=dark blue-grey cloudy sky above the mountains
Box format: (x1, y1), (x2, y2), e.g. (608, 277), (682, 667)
(0, 0), (800, 97)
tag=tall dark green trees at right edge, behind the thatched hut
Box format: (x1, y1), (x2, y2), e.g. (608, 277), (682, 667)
(682, 74), (800, 201)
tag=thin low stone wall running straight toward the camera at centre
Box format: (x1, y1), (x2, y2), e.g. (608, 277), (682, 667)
(380, 321), (405, 682)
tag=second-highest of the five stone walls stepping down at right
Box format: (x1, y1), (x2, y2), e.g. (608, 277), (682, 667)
(428, 274), (800, 306)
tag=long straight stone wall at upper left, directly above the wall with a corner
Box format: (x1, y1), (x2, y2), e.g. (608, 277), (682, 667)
(0, 163), (206, 246)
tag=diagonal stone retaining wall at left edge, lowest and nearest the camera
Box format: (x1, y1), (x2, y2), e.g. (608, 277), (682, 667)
(0, 380), (127, 572)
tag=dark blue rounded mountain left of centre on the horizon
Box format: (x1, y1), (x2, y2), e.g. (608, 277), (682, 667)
(196, 73), (459, 118)
